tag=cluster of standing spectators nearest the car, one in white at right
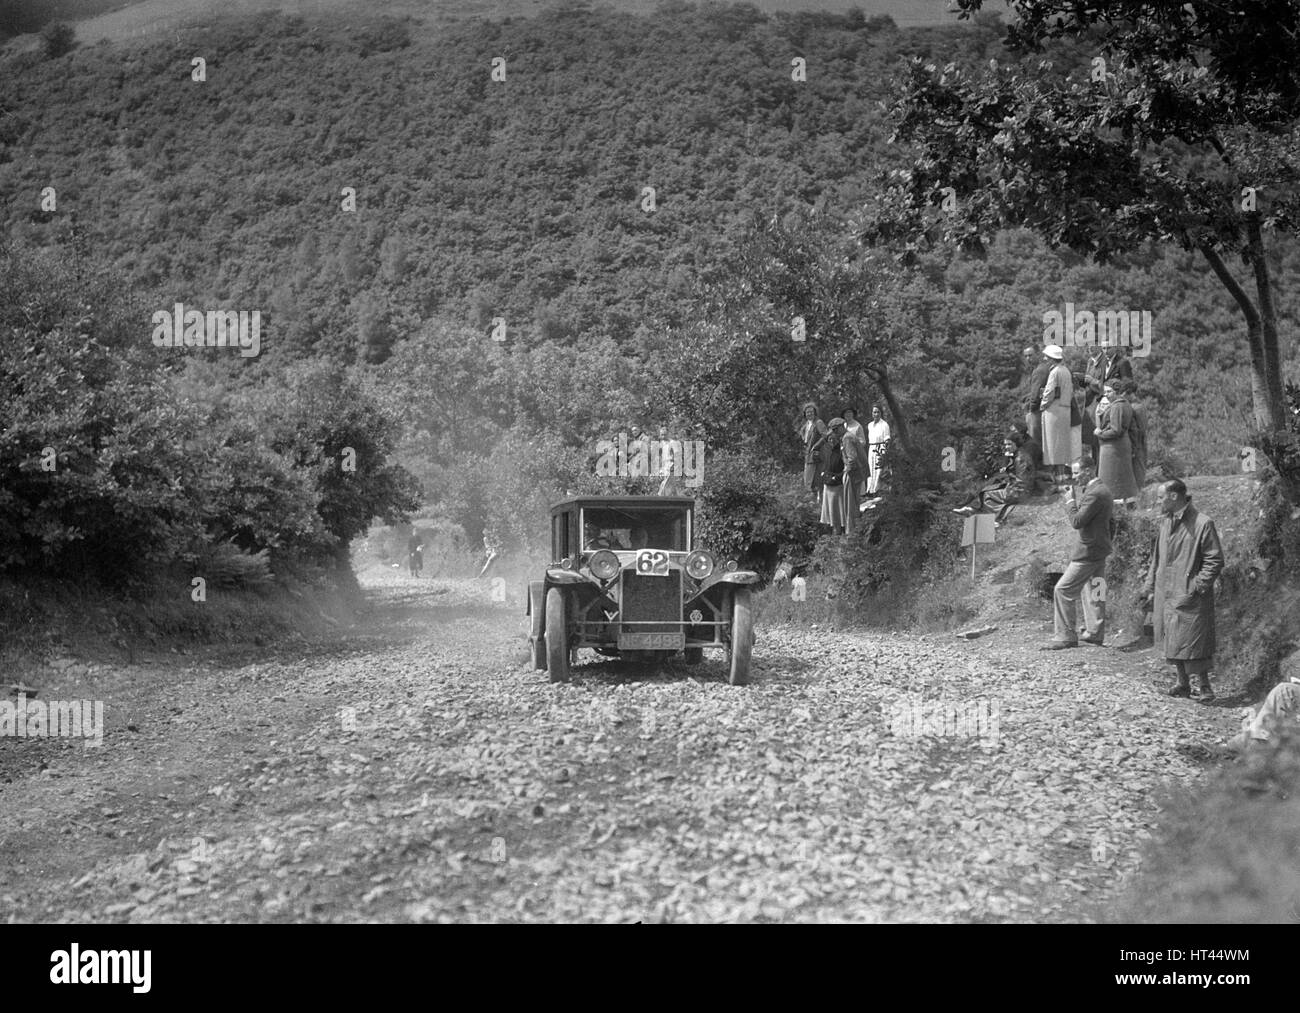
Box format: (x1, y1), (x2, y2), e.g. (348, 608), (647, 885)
(794, 402), (892, 534)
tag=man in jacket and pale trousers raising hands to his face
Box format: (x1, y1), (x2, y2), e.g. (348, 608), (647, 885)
(1041, 456), (1114, 650)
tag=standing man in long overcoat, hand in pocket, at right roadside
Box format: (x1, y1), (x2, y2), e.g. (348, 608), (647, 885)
(1143, 479), (1223, 704)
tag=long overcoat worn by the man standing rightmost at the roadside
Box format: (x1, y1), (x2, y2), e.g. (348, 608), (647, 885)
(1145, 503), (1223, 661)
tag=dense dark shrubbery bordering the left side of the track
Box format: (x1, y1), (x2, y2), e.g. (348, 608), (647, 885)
(0, 240), (417, 580)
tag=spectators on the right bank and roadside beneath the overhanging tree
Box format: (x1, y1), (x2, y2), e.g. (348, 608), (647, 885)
(954, 345), (1300, 752)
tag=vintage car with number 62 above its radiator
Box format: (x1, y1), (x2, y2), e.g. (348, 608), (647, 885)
(527, 495), (758, 685)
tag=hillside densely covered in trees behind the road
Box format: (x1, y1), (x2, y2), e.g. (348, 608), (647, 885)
(0, 0), (1300, 566)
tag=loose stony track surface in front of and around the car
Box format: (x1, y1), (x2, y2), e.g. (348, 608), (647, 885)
(0, 559), (1236, 922)
